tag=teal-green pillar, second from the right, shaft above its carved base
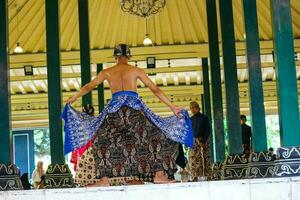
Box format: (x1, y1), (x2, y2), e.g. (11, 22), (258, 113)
(243, 0), (267, 152)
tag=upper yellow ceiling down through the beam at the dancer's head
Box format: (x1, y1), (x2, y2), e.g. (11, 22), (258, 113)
(9, 0), (300, 66)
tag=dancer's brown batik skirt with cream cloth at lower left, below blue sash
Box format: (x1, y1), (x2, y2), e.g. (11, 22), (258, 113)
(75, 106), (178, 186)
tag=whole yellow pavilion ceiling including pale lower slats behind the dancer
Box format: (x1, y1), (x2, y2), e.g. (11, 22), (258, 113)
(4, 0), (300, 128)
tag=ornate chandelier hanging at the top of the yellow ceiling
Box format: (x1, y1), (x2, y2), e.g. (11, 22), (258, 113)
(120, 0), (166, 18)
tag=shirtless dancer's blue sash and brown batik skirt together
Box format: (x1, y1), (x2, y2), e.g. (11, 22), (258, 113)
(63, 92), (193, 186)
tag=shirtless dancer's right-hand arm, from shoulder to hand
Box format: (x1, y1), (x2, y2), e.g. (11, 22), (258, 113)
(138, 69), (181, 115)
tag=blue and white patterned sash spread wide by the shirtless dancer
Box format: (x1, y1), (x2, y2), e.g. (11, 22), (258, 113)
(62, 91), (193, 154)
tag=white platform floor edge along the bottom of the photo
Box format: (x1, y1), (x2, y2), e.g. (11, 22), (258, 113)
(0, 177), (300, 200)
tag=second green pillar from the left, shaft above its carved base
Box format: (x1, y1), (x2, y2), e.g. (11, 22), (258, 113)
(46, 0), (65, 163)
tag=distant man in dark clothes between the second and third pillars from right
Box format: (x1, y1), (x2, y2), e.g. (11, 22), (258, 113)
(241, 115), (252, 158)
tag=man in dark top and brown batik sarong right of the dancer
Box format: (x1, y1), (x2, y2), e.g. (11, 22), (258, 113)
(189, 101), (211, 181)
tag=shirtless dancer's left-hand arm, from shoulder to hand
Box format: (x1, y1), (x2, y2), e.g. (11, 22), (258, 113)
(67, 70), (106, 104)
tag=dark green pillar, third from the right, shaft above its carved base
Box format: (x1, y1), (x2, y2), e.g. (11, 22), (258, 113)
(219, 0), (242, 155)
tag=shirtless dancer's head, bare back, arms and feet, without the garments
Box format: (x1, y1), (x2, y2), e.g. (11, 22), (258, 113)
(67, 44), (181, 185)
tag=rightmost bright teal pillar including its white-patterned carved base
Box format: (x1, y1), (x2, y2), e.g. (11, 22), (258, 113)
(270, 0), (300, 177)
